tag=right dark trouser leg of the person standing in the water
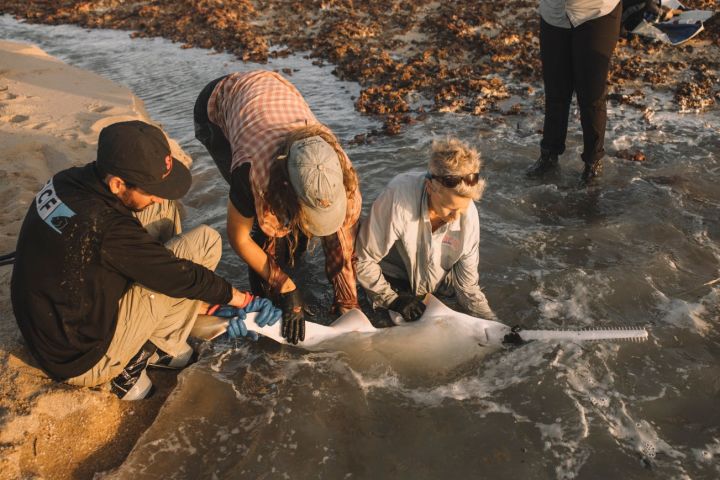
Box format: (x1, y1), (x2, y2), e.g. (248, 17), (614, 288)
(572, 3), (622, 168)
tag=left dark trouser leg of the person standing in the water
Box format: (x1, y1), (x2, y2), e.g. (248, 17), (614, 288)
(540, 19), (574, 155)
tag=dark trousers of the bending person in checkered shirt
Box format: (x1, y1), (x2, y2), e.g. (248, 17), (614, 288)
(193, 76), (232, 183)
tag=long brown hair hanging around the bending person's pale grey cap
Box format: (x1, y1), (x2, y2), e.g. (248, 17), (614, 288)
(265, 123), (358, 266)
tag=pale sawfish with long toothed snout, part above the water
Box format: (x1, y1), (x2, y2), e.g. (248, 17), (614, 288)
(191, 294), (648, 350)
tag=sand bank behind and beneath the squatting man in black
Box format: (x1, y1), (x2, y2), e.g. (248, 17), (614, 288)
(0, 41), (190, 479)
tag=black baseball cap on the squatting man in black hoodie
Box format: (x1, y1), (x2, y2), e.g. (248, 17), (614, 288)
(96, 120), (192, 200)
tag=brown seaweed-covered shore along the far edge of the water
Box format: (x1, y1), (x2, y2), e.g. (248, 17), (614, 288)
(0, 0), (720, 137)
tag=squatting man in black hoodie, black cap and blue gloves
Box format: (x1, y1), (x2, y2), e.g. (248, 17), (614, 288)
(11, 121), (280, 400)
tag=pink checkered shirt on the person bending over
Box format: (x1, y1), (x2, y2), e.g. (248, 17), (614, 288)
(208, 70), (362, 308)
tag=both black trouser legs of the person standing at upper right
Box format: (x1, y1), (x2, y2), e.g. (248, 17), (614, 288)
(540, 2), (622, 163)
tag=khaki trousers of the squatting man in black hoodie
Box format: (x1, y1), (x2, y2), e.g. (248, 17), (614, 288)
(67, 201), (222, 387)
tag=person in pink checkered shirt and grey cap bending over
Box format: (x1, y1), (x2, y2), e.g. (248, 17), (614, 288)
(194, 70), (362, 344)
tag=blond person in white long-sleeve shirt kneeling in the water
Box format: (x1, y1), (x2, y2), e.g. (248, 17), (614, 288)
(356, 139), (495, 321)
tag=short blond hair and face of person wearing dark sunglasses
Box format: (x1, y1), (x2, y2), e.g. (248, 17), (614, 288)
(428, 137), (485, 200)
